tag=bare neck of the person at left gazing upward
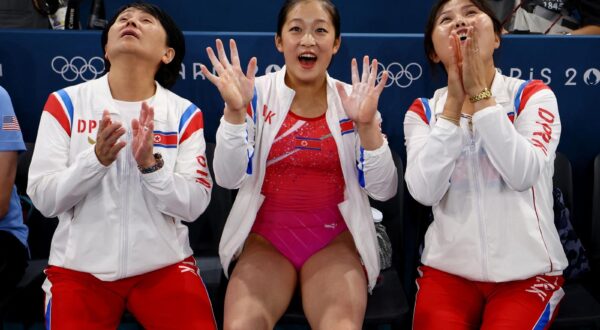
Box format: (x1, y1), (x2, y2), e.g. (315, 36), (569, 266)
(108, 62), (156, 102)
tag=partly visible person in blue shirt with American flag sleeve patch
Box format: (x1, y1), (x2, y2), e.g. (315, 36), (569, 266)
(0, 87), (29, 299)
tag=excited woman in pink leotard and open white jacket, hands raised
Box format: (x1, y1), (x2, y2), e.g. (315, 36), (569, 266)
(202, 0), (397, 329)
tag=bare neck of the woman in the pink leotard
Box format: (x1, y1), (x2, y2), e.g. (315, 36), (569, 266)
(286, 76), (327, 118)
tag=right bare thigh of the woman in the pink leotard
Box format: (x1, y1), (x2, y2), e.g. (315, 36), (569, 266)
(300, 231), (367, 329)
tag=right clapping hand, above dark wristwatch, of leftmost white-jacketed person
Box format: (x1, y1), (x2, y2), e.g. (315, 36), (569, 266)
(131, 102), (155, 168)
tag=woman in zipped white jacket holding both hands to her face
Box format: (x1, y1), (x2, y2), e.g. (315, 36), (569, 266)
(404, 0), (567, 329)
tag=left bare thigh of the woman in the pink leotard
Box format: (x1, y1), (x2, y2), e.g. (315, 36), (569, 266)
(224, 234), (297, 330)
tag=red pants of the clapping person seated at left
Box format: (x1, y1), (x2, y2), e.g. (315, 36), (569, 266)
(44, 257), (216, 330)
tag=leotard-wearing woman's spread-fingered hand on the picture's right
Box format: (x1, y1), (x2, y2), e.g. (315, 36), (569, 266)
(336, 56), (388, 126)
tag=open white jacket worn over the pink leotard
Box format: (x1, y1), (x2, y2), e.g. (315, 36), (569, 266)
(214, 67), (398, 290)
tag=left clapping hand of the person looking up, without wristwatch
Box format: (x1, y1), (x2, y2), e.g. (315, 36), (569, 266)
(94, 110), (125, 166)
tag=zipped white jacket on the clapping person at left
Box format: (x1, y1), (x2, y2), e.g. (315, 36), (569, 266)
(27, 76), (212, 281)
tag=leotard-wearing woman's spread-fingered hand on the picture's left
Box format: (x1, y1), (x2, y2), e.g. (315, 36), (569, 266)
(200, 39), (256, 121)
